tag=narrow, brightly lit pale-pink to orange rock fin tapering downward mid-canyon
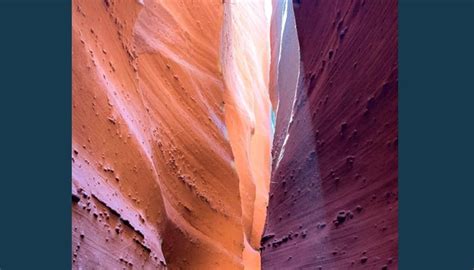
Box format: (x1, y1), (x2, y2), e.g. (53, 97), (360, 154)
(222, 0), (272, 269)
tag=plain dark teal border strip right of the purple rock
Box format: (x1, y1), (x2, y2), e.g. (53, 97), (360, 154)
(399, 0), (474, 269)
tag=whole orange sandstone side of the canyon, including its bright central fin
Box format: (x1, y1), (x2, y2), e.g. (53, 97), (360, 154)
(72, 0), (272, 269)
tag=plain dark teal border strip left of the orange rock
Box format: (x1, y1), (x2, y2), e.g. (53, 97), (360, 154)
(0, 0), (71, 270)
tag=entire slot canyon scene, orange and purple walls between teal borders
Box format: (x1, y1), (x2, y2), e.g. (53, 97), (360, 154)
(71, 0), (398, 269)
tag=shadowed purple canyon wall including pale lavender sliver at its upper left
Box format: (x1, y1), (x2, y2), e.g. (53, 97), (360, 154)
(261, 0), (398, 269)
